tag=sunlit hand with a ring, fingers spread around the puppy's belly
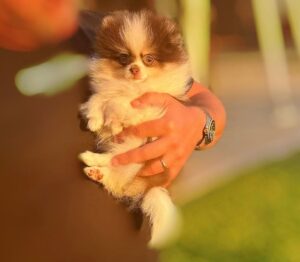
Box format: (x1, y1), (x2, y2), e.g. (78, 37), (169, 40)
(112, 93), (205, 187)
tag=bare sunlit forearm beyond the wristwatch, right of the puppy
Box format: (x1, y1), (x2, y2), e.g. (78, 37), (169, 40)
(187, 82), (226, 149)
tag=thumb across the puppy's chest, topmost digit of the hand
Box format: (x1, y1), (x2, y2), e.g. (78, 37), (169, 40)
(131, 93), (172, 107)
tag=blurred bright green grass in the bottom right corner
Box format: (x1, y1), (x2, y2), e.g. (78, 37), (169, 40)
(161, 153), (300, 262)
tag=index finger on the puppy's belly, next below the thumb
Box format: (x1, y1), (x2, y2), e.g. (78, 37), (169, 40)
(118, 117), (175, 139)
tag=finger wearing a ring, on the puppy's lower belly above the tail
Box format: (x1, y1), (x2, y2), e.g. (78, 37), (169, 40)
(138, 154), (177, 177)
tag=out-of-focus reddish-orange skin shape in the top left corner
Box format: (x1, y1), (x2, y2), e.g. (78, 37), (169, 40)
(0, 0), (78, 51)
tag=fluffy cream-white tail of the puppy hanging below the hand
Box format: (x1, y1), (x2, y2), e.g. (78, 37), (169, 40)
(141, 187), (180, 248)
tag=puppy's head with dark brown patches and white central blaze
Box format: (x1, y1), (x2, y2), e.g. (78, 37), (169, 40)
(95, 11), (187, 82)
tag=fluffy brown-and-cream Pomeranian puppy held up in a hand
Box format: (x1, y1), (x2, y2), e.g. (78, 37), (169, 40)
(80, 11), (191, 247)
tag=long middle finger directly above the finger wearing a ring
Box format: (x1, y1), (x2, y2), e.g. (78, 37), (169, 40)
(112, 138), (170, 166)
